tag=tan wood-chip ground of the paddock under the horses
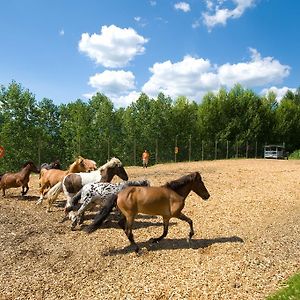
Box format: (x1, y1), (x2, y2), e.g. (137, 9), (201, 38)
(0, 160), (300, 300)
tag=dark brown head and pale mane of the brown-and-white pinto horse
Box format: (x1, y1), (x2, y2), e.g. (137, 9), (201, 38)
(99, 157), (128, 182)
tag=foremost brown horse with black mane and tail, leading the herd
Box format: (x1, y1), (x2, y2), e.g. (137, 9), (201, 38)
(86, 172), (210, 252)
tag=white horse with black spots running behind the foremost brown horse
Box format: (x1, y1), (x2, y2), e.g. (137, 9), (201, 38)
(65, 180), (150, 230)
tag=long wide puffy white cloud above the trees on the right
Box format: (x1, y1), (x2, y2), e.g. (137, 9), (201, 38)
(142, 49), (290, 101)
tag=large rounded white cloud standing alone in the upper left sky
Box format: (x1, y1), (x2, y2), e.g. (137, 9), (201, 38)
(78, 25), (148, 68)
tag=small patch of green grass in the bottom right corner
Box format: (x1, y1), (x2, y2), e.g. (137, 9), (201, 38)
(267, 273), (300, 300)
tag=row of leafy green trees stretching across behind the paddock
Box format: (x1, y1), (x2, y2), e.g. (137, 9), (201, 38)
(0, 81), (300, 173)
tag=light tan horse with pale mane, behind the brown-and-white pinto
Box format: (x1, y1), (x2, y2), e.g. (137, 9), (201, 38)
(37, 156), (97, 204)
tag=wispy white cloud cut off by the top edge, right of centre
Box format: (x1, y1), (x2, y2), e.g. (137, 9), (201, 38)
(202, 0), (256, 30)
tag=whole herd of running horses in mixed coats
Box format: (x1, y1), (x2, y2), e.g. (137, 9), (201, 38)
(0, 156), (210, 253)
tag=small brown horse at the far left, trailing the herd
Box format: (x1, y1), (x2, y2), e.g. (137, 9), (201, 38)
(0, 161), (39, 197)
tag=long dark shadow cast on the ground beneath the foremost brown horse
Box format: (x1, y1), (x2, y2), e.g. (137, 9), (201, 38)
(102, 236), (244, 256)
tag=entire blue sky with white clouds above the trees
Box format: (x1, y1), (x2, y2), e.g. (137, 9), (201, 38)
(0, 0), (300, 107)
